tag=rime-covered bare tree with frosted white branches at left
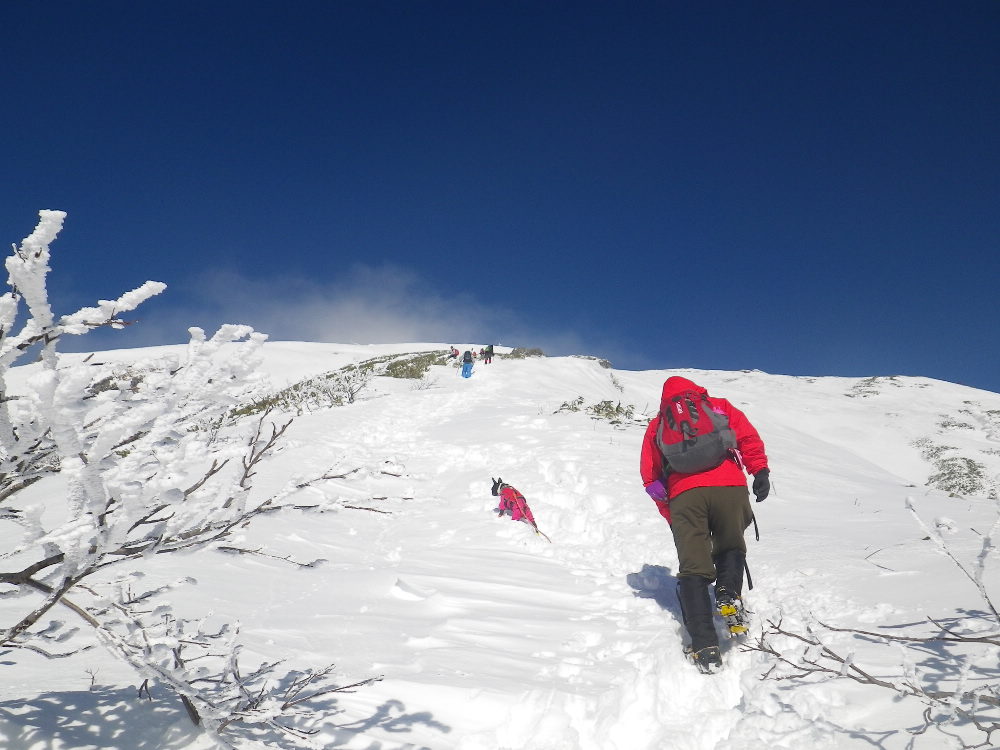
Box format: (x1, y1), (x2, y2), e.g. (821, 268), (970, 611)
(0, 211), (378, 747)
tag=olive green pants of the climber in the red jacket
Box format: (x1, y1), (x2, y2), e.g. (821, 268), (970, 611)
(670, 485), (753, 581)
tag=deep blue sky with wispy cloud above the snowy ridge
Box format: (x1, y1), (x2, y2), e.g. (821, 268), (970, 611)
(0, 0), (1000, 391)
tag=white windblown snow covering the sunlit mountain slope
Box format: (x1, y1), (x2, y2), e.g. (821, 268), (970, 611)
(0, 342), (1000, 750)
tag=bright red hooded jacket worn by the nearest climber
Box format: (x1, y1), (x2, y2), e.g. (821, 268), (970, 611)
(639, 376), (767, 521)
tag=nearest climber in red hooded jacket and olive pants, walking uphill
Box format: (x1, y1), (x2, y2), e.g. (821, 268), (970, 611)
(639, 377), (771, 672)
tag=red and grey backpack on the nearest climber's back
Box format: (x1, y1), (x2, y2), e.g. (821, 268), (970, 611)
(656, 391), (736, 474)
